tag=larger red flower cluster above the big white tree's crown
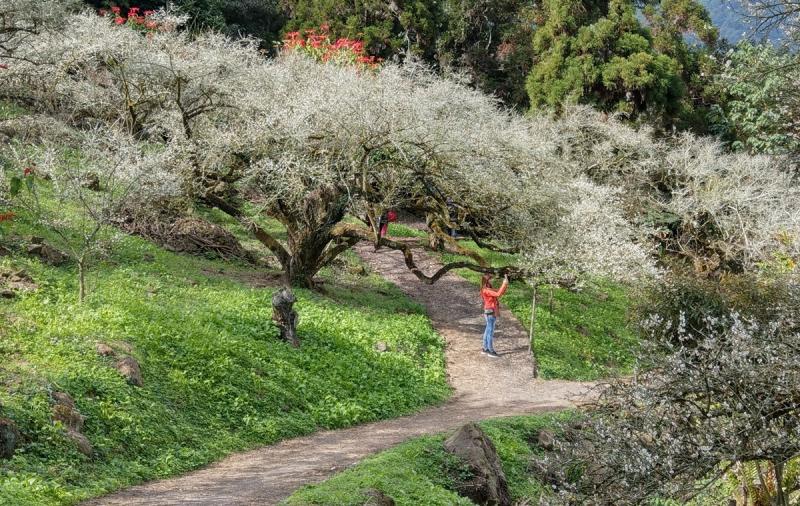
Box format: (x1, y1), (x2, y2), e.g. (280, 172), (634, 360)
(283, 24), (382, 69)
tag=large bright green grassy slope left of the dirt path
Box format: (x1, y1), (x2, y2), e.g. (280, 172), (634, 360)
(0, 211), (449, 505)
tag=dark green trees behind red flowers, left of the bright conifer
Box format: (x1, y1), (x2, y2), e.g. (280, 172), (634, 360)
(278, 0), (534, 109)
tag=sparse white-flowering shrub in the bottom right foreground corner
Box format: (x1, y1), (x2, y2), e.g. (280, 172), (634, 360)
(539, 279), (800, 506)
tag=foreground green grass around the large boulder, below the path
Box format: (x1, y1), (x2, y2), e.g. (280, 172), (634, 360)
(285, 412), (572, 506)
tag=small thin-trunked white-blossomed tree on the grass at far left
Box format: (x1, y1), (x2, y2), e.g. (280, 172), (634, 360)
(0, 125), (180, 301)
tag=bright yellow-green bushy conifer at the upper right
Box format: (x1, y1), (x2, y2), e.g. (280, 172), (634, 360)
(527, 0), (716, 126)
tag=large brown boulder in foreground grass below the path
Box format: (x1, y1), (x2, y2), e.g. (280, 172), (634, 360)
(444, 422), (511, 506)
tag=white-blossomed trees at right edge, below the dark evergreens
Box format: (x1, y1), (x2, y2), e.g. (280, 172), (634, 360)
(557, 108), (800, 274)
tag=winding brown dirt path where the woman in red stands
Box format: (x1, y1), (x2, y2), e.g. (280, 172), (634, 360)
(85, 244), (588, 506)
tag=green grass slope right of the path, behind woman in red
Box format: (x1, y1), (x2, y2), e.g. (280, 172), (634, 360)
(391, 224), (638, 380)
